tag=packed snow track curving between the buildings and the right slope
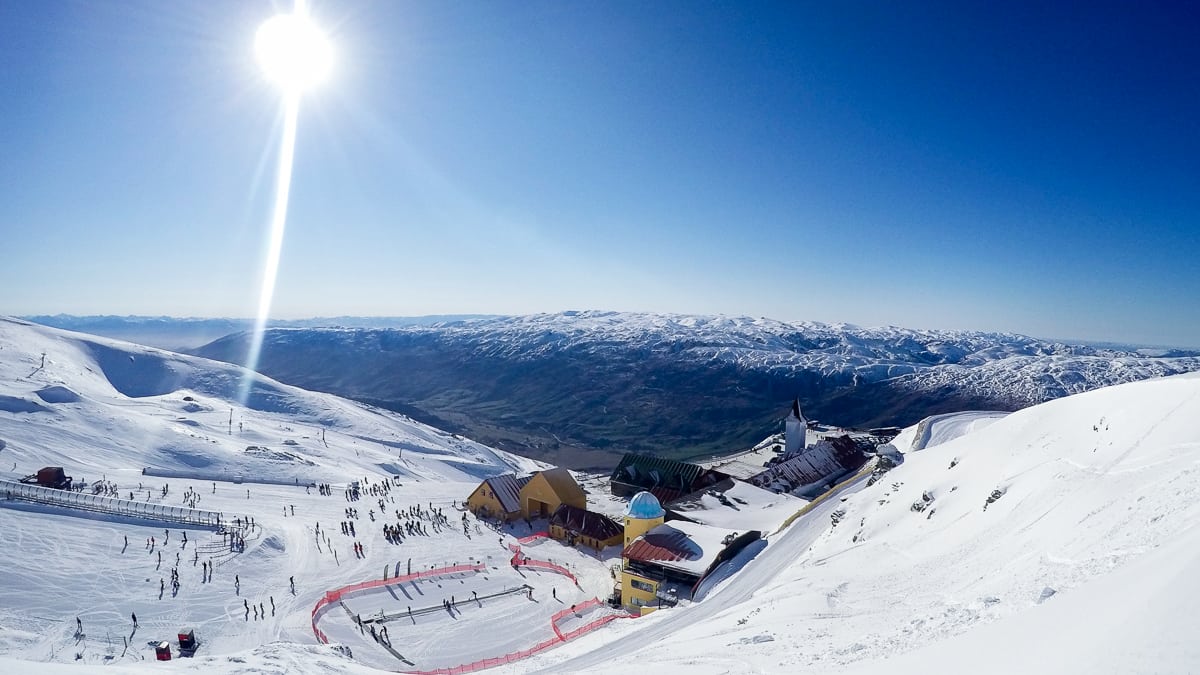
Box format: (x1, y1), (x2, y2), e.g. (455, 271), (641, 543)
(533, 476), (869, 674)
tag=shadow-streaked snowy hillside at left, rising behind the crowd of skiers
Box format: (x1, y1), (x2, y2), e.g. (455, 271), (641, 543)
(0, 318), (534, 483)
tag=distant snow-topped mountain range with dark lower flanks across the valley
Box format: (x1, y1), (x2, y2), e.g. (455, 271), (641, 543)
(184, 311), (1200, 467)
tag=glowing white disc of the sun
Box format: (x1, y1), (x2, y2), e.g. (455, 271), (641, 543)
(254, 13), (334, 95)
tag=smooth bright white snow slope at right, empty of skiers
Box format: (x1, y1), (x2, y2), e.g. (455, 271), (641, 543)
(518, 375), (1200, 673)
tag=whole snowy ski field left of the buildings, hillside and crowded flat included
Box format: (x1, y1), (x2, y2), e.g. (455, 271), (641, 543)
(0, 319), (611, 673)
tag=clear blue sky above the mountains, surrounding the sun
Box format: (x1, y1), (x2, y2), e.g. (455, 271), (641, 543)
(0, 0), (1200, 346)
